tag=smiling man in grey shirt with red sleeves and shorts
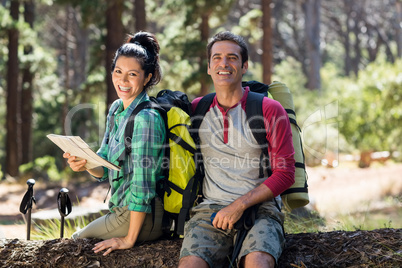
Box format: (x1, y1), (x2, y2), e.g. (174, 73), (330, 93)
(179, 32), (294, 268)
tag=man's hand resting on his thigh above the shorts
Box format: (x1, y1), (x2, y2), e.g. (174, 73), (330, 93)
(212, 202), (245, 230)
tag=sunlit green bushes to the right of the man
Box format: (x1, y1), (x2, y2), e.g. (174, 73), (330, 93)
(273, 58), (402, 165)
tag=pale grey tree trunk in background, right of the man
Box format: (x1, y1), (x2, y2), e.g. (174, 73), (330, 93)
(304, 0), (321, 90)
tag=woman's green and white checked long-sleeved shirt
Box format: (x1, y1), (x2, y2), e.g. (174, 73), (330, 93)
(97, 91), (166, 213)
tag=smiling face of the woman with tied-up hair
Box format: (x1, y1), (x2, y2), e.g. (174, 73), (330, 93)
(112, 56), (152, 109)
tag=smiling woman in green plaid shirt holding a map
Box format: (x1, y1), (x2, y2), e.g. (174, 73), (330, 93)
(63, 32), (166, 255)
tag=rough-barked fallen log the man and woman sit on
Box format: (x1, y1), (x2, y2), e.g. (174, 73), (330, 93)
(0, 229), (402, 268)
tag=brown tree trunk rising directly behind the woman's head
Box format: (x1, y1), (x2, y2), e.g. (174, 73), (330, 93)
(105, 0), (124, 107)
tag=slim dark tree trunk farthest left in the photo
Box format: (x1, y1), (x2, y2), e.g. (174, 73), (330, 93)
(5, 0), (21, 177)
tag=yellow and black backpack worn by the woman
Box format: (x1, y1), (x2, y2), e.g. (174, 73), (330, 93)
(118, 89), (201, 236)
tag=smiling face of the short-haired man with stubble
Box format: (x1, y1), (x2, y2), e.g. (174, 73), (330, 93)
(208, 41), (248, 86)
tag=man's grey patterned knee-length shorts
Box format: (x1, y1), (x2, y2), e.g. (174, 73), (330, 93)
(180, 205), (285, 268)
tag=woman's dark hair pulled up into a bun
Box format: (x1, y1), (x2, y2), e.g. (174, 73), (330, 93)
(112, 32), (162, 90)
